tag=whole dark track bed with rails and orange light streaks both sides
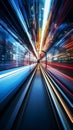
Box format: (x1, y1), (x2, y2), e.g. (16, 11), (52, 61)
(0, 64), (73, 130)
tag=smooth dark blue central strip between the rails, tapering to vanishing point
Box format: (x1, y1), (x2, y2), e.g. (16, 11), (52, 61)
(13, 65), (58, 130)
